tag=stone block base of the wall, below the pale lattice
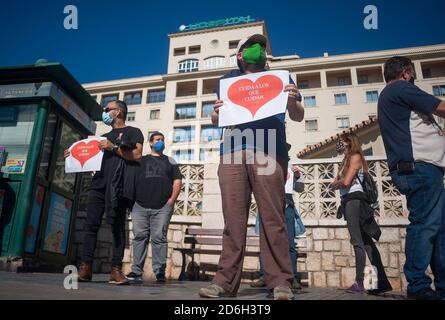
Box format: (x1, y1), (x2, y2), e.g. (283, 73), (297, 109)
(72, 212), (406, 291)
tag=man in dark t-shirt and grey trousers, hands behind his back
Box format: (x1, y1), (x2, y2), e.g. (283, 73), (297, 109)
(127, 132), (182, 283)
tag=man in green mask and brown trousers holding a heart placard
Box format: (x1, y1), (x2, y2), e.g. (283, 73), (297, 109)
(199, 34), (304, 300)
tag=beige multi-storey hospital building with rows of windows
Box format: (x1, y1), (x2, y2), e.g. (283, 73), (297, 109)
(84, 19), (445, 163)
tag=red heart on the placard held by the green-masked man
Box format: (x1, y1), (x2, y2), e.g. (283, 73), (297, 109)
(227, 75), (283, 117)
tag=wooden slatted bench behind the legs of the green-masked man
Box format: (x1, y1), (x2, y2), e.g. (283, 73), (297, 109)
(173, 227), (307, 281)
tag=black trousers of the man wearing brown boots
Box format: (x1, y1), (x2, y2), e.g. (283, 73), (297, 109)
(81, 189), (127, 267)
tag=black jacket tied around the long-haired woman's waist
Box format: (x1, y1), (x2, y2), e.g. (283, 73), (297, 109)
(337, 191), (382, 241)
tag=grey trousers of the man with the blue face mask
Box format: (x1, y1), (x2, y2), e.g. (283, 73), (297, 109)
(131, 203), (173, 275)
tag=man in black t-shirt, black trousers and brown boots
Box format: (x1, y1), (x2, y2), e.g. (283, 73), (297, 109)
(65, 100), (144, 284)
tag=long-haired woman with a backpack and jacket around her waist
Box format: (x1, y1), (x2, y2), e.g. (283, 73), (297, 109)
(331, 133), (392, 294)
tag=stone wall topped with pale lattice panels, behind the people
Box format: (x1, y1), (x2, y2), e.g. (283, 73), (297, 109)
(72, 159), (416, 291)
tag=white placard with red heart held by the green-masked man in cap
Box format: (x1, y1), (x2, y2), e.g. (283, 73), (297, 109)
(219, 70), (289, 127)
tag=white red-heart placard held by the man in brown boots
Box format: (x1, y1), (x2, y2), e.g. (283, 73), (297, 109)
(65, 137), (106, 173)
